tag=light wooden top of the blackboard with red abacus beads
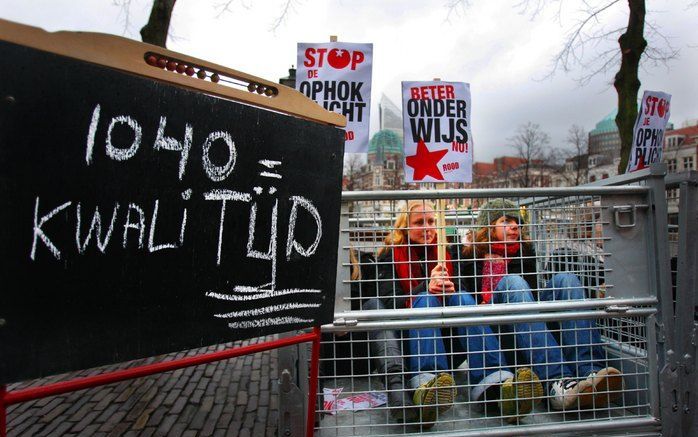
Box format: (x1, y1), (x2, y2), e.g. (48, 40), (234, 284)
(0, 19), (346, 127)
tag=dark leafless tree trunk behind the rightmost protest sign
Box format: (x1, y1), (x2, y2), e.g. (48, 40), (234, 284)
(613, 0), (647, 174)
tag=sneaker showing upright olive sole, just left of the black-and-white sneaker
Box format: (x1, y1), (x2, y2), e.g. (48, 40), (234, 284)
(499, 367), (543, 423)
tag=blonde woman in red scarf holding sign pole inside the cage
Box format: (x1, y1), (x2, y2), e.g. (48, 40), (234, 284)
(363, 200), (456, 427)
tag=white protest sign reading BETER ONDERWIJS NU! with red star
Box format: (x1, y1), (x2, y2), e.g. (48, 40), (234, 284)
(402, 81), (473, 182)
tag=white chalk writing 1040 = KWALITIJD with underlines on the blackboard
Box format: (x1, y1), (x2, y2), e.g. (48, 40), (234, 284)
(29, 100), (322, 328)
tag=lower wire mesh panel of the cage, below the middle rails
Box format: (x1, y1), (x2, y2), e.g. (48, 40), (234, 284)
(317, 317), (650, 436)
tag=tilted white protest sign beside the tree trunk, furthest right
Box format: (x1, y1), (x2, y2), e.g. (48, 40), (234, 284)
(626, 91), (671, 173)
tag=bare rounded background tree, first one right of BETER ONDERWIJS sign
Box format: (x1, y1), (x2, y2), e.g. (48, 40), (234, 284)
(509, 121), (551, 187)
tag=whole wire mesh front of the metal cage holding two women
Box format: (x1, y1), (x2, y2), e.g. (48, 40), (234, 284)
(316, 187), (657, 436)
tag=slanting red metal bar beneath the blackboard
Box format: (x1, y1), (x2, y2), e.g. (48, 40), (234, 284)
(3, 334), (315, 406)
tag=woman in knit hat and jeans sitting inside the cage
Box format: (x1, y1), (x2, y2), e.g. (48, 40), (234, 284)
(459, 199), (623, 410)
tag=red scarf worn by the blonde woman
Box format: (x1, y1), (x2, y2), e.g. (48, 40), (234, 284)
(393, 244), (453, 308)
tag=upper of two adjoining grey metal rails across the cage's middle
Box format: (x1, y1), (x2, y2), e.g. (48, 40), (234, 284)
(334, 297), (657, 321)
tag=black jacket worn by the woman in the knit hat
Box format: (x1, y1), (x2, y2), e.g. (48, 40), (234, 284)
(456, 244), (538, 303)
